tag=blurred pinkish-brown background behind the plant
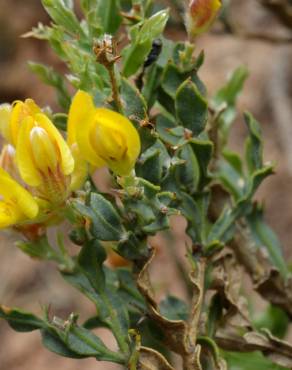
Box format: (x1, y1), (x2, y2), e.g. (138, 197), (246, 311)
(0, 0), (292, 370)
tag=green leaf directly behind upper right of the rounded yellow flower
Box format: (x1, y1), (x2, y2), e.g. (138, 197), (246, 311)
(121, 78), (147, 121)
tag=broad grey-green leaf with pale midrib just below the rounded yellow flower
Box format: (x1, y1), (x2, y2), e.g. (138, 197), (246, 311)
(90, 193), (124, 241)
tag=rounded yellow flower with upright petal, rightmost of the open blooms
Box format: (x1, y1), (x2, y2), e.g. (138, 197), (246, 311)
(68, 90), (140, 175)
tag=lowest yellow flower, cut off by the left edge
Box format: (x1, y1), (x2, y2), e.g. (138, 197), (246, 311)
(0, 167), (38, 229)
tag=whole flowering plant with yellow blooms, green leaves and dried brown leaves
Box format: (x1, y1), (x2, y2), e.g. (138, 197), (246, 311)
(0, 0), (292, 370)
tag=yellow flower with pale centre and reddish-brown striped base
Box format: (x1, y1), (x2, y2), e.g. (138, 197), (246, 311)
(16, 113), (74, 206)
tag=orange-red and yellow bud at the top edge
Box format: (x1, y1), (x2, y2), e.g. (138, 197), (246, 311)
(186, 0), (222, 38)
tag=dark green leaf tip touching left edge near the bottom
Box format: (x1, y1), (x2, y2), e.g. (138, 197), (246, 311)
(0, 305), (45, 332)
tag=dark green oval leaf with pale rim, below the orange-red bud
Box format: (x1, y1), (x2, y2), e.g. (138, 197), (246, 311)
(175, 79), (208, 136)
